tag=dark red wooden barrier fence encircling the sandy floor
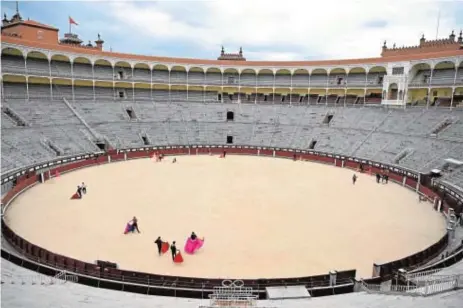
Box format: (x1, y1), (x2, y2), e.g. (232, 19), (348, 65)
(2, 145), (460, 297)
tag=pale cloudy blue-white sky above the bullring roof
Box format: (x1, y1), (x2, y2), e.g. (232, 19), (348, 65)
(2, 0), (463, 61)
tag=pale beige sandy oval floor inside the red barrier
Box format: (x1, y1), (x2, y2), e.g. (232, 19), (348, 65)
(6, 155), (445, 278)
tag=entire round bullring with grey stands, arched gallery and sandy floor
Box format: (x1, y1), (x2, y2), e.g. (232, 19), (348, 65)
(1, 2), (463, 308)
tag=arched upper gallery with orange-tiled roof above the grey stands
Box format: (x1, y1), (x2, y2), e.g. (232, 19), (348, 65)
(1, 11), (463, 106)
